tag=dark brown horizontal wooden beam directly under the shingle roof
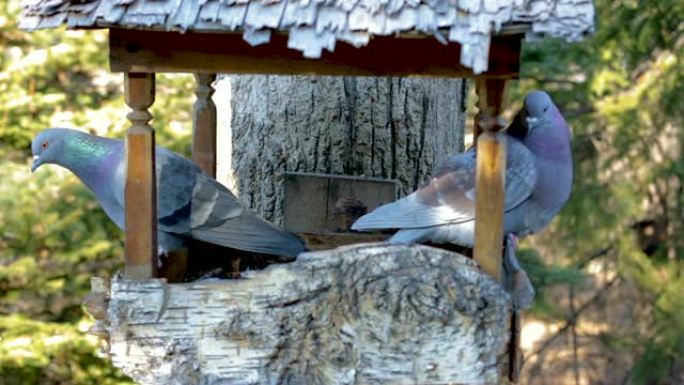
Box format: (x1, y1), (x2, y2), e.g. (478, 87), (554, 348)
(109, 29), (523, 78)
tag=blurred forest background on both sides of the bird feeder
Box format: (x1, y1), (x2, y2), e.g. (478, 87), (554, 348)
(0, 0), (684, 385)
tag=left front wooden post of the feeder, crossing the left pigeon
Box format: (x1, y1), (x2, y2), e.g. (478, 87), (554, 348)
(124, 73), (157, 279)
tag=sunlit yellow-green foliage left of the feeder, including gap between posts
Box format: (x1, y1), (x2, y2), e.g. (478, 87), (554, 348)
(0, 1), (194, 385)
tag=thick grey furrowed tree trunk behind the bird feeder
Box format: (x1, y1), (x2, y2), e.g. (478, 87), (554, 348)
(224, 75), (467, 224)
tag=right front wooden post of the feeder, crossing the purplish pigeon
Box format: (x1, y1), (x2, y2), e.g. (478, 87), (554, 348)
(473, 78), (506, 281)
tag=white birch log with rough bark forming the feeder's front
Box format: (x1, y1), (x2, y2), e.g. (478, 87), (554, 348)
(87, 244), (511, 385)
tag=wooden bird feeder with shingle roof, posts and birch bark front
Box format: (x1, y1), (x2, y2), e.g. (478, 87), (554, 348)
(21, 0), (594, 384)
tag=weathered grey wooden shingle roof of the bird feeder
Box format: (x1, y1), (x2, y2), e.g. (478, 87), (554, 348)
(20, 0), (594, 73)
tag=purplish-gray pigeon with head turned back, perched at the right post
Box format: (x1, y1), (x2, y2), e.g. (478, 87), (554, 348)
(352, 91), (572, 247)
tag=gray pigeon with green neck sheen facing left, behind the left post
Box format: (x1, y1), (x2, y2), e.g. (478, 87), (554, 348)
(31, 128), (304, 256)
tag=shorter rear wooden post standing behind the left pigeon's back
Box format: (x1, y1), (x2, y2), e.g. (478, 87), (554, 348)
(192, 74), (216, 177)
